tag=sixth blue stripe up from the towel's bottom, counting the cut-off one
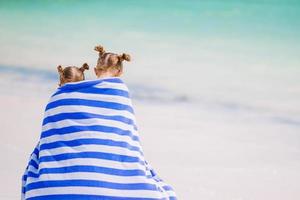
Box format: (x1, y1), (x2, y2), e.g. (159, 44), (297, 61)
(41, 125), (139, 141)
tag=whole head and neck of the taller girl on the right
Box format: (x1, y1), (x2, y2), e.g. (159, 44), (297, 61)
(94, 45), (130, 78)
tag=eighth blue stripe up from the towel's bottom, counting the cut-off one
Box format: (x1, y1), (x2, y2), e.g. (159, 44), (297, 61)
(46, 98), (134, 113)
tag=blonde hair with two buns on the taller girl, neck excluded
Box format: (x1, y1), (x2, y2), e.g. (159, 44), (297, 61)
(94, 45), (131, 71)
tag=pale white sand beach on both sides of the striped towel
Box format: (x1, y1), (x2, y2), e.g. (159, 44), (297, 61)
(0, 83), (300, 200)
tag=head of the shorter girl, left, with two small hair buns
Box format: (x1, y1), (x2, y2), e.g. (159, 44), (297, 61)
(57, 63), (89, 86)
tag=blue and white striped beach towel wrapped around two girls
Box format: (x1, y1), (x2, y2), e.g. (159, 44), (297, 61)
(22, 77), (176, 200)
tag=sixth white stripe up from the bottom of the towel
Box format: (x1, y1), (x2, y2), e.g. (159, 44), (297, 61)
(42, 118), (138, 136)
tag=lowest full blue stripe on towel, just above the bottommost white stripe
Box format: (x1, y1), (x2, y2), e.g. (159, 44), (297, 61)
(26, 179), (157, 191)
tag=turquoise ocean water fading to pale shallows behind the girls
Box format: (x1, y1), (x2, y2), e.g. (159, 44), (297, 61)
(0, 0), (300, 122)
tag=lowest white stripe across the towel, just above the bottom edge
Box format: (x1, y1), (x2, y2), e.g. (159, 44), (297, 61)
(26, 187), (162, 198)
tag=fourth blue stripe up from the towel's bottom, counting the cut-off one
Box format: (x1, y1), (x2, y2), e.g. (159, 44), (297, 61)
(40, 151), (144, 165)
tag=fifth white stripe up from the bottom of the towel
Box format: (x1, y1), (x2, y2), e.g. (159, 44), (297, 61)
(40, 131), (141, 152)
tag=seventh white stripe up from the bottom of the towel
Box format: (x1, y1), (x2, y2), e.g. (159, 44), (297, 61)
(44, 105), (135, 124)
